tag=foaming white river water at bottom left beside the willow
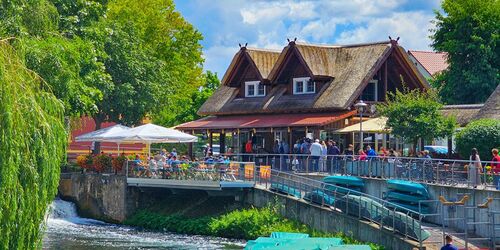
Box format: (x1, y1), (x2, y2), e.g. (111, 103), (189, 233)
(43, 199), (243, 250)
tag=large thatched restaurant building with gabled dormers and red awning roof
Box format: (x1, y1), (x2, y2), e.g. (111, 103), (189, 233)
(177, 40), (429, 155)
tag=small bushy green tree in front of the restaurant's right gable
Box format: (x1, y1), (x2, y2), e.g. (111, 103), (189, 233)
(377, 89), (456, 152)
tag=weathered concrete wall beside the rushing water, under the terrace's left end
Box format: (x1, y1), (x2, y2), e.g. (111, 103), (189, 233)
(59, 173), (139, 222)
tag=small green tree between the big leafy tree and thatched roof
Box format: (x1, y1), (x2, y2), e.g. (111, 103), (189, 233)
(154, 71), (220, 127)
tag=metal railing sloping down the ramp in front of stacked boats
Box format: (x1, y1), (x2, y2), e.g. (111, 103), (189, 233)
(255, 166), (437, 247)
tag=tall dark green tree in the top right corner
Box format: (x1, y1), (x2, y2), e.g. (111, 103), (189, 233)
(432, 0), (500, 104)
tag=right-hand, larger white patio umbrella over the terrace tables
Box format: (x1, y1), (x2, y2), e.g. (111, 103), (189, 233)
(109, 123), (198, 155)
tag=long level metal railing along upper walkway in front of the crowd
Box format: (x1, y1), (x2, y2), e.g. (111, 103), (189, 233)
(226, 154), (500, 188)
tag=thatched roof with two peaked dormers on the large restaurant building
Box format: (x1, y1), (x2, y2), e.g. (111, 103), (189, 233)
(198, 41), (428, 115)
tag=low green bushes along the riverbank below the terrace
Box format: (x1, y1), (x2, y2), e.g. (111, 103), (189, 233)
(124, 206), (381, 249)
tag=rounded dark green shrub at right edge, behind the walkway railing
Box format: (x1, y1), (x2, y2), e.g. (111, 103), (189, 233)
(456, 119), (500, 161)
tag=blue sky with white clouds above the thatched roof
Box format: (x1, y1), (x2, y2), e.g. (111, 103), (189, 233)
(174, 0), (440, 78)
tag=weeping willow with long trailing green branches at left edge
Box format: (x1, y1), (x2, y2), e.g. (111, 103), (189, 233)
(0, 41), (67, 249)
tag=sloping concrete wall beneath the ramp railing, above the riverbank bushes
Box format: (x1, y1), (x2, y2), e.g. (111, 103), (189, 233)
(245, 188), (418, 250)
